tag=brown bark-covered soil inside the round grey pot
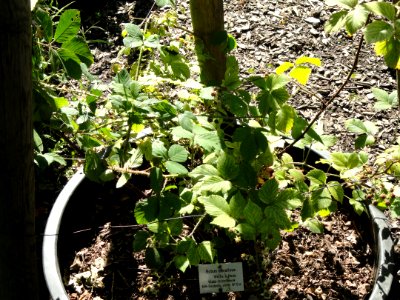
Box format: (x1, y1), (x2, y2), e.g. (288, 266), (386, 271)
(60, 184), (374, 300)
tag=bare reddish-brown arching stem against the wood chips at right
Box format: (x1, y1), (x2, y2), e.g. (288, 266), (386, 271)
(278, 35), (364, 155)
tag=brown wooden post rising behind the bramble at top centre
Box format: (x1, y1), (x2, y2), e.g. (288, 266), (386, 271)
(190, 0), (227, 86)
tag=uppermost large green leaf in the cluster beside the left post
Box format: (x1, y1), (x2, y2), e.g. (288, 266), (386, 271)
(54, 9), (81, 43)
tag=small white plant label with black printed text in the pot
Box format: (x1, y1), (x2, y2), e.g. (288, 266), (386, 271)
(199, 262), (244, 294)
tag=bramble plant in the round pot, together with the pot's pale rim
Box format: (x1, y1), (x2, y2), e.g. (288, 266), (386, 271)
(37, 1), (399, 299)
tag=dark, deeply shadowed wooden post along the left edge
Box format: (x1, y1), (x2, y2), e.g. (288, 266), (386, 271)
(0, 0), (38, 300)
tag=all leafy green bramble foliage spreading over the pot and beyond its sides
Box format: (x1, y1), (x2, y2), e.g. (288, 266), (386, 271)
(34, 0), (400, 292)
